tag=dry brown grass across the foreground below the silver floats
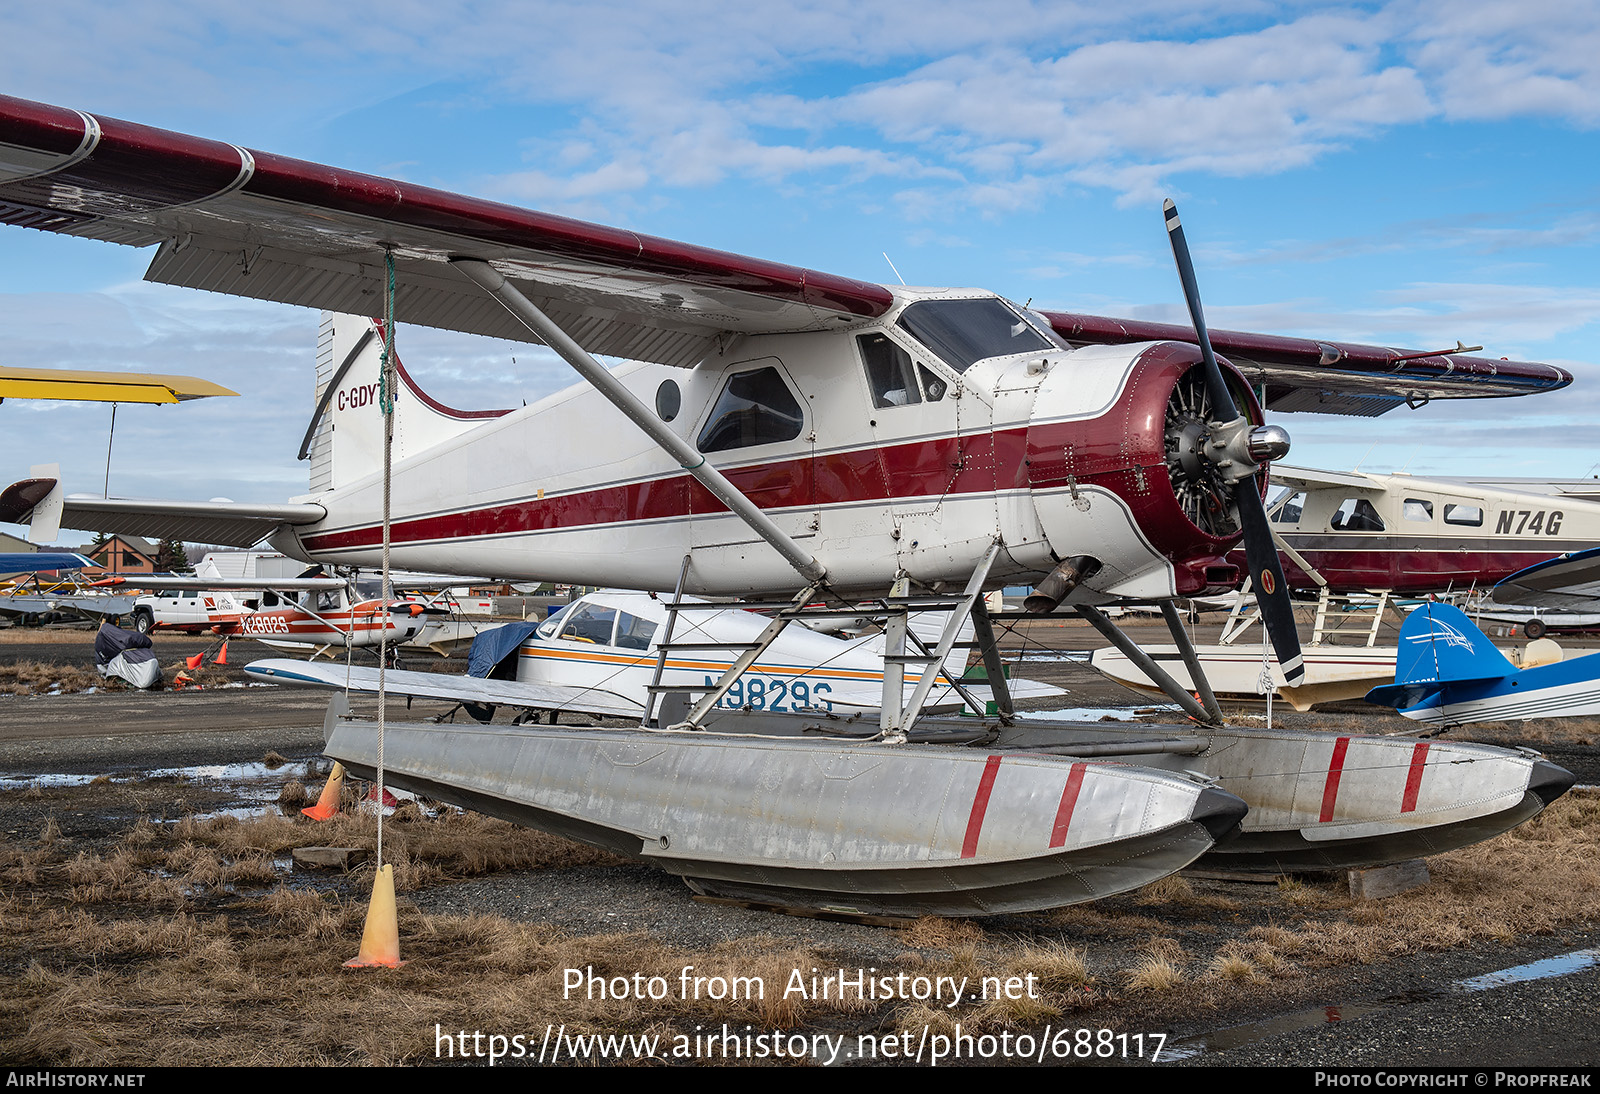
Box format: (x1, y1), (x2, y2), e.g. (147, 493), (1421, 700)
(0, 777), (1600, 1067)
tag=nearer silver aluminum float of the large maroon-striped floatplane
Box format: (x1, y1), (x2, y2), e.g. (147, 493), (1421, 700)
(326, 696), (1246, 916)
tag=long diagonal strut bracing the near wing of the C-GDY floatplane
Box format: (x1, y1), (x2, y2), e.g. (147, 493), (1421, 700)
(451, 258), (827, 584)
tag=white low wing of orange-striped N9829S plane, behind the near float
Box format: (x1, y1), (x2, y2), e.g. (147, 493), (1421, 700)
(245, 657), (645, 720)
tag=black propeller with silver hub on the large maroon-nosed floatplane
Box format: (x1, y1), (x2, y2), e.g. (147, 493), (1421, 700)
(1163, 198), (1306, 686)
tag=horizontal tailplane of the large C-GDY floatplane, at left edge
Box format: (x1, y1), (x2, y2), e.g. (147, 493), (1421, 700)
(0, 478), (328, 547)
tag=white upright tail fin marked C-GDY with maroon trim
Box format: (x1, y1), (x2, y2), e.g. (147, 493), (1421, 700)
(301, 312), (509, 494)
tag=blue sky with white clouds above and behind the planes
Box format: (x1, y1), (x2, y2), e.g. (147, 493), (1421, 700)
(0, 0), (1600, 547)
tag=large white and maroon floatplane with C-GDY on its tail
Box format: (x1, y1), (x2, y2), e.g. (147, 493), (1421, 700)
(0, 99), (1571, 915)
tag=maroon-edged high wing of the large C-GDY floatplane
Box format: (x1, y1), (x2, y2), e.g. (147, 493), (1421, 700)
(0, 98), (1571, 406)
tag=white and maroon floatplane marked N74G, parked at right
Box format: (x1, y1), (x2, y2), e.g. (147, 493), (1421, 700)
(1091, 464), (1600, 710)
